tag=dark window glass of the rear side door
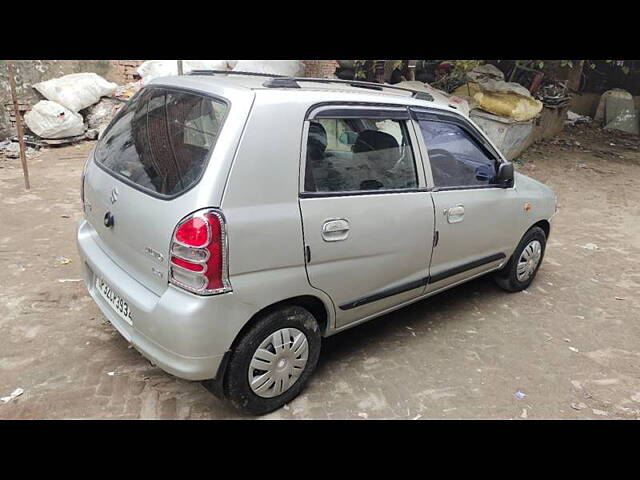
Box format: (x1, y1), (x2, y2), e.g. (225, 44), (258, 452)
(305, 118), (418, 193)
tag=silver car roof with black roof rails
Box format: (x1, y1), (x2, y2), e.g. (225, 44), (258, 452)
(149, 73), (462, 113)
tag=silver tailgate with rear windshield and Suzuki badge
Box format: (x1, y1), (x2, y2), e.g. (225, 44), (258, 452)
(84, 87), (228, 295)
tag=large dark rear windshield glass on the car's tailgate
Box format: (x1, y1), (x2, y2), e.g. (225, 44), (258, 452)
(94, 87), (228, 197)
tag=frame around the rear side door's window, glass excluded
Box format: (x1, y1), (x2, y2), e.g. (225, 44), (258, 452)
(298, 102), (430, 198)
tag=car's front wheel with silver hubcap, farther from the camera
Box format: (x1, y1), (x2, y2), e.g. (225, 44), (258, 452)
(493, 227), (547, 292)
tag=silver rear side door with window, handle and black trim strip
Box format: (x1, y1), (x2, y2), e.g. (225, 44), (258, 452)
(300, 106), (433, 326)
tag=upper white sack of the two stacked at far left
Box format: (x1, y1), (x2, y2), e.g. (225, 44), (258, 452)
(33, 72), (118, 112)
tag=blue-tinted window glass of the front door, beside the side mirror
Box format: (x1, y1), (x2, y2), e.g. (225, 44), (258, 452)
(418, 120), (497, 187)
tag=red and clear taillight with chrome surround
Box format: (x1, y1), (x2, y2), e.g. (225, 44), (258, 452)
(169, 209), (231, 295)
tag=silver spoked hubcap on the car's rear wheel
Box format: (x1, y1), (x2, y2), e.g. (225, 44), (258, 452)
(249, 328), (309, 398)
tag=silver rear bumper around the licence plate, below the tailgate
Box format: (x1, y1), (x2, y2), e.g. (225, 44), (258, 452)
(77, 220), (233, 380)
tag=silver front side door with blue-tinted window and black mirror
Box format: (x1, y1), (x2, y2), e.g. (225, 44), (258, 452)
(416, 109), (519, 291)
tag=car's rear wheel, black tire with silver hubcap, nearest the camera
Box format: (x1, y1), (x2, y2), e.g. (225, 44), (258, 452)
(224, 306), (321, 415)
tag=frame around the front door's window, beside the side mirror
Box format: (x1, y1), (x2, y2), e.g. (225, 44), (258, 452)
(409, 107), (515, 192)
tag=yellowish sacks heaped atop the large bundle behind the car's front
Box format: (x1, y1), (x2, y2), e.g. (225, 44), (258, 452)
(453, 64), (543, 121)
